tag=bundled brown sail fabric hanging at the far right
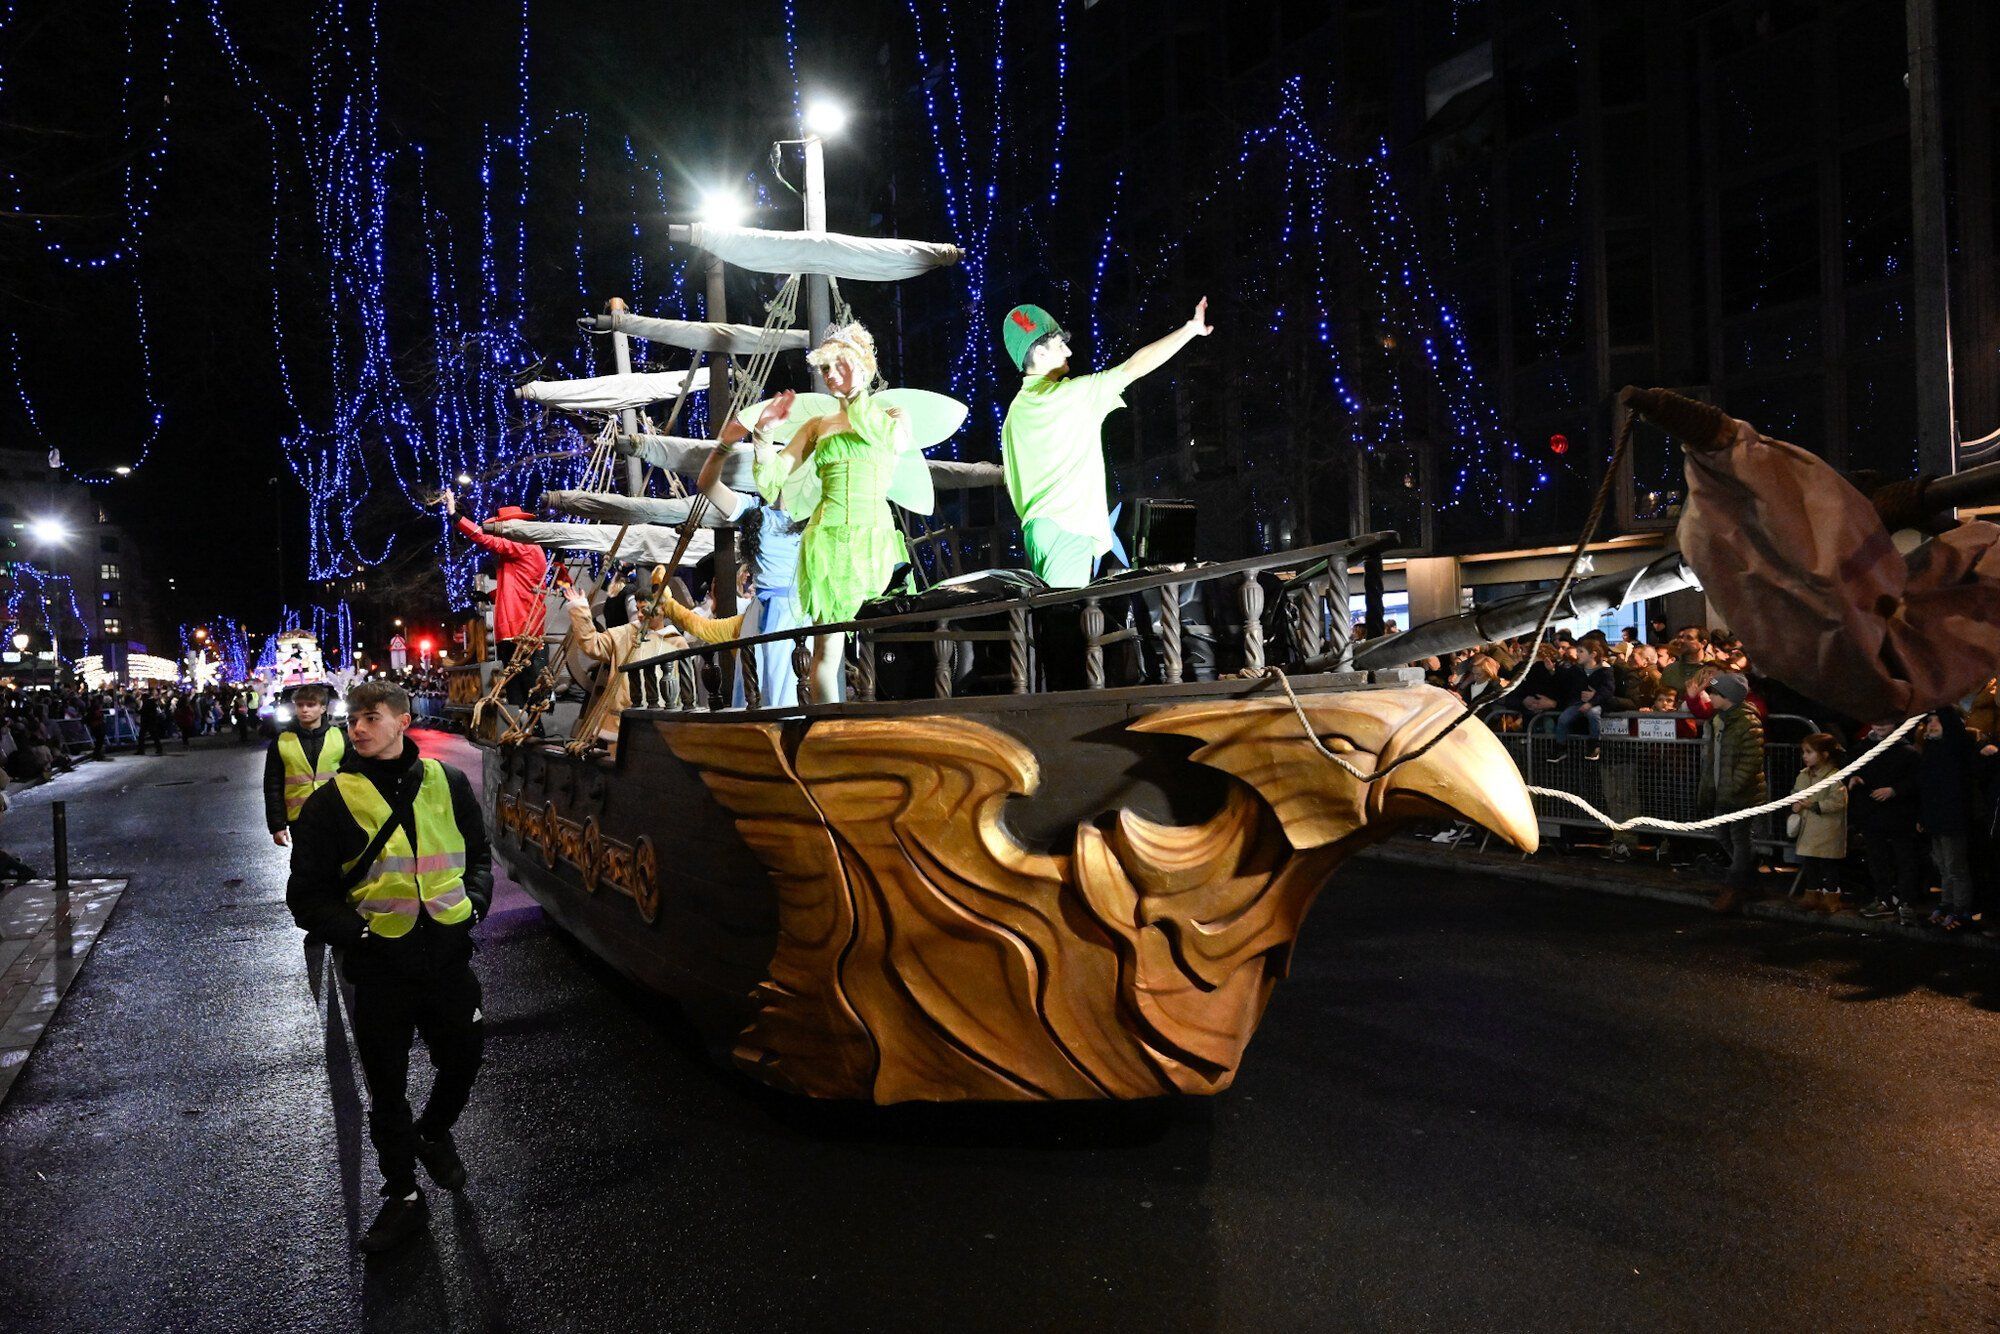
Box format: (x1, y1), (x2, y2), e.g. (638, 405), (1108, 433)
(1680, 418), (2000, 722)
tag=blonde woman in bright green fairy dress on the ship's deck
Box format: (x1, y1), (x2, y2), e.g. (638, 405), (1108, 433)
(752, 324), (912, 702)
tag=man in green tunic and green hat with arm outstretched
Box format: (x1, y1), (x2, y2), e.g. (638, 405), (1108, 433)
(1000, 296), (1214, 588)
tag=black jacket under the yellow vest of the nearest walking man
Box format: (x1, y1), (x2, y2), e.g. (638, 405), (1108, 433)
(284, 740), (494, 982)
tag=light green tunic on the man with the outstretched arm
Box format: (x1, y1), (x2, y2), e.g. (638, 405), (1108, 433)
(1000, 366), (1132, 588)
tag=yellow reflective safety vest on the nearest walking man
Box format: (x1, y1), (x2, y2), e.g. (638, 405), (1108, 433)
(334, 760), (472, 940)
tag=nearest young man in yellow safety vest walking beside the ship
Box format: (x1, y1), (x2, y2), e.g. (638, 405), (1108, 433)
(284, 680), (494, 1252)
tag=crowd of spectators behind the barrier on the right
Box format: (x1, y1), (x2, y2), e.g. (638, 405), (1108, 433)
(1392, 624), (2000, 934)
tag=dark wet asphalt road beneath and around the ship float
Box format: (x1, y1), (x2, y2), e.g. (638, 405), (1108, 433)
(0, 734), (2000, 1332)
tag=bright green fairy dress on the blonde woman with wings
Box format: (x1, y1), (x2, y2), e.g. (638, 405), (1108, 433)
(756, 394), (906, 626)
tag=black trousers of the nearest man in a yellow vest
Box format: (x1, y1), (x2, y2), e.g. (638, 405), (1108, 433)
(354, 964), (486, 1196)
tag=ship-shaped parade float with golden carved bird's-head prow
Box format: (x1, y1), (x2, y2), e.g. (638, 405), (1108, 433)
(464, 204), (1538, 1104)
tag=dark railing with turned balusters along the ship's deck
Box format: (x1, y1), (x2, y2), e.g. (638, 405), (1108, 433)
(620, 532), (1398, 712)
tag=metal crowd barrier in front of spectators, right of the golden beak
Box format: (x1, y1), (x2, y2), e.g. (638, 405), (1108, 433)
(1500, 714), (1820, 850)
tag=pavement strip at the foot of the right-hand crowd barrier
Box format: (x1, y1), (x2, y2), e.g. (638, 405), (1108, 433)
(1360, 830), (2000, 952)
